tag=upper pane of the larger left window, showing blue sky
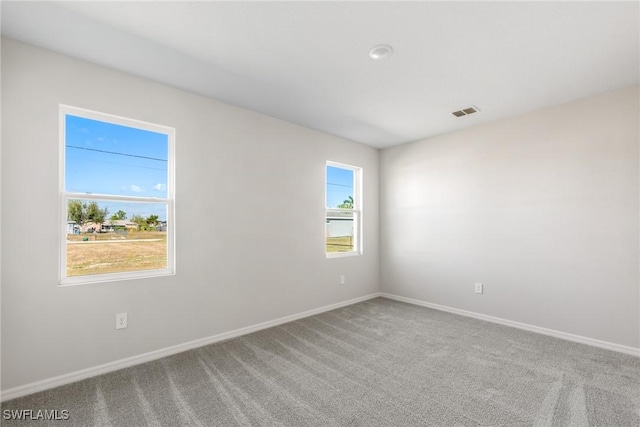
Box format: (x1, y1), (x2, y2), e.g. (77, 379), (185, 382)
(65, 115), (168, 198)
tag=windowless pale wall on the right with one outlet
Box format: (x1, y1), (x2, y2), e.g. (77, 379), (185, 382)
(380, 86), (640, 348)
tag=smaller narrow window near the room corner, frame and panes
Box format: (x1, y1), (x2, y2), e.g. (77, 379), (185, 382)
(325, 162), (362, 257)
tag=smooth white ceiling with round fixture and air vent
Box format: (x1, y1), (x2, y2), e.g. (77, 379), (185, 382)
(2, 1), (640, 148)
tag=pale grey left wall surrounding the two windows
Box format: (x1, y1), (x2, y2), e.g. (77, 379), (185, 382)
(1, 39), (379, 390)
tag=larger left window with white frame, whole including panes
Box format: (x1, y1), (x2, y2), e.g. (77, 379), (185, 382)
(60, 105), (175, 285)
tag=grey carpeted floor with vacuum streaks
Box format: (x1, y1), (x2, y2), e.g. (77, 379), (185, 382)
(2, 298), (640, 426)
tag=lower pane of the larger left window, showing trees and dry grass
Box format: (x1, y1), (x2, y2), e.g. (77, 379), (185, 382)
(66, 200), (167, 277)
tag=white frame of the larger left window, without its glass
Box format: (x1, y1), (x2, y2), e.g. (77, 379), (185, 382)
(58, 104), (176, 286)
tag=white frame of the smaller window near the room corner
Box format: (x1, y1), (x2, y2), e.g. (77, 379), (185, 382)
(324, 160), (363, 258)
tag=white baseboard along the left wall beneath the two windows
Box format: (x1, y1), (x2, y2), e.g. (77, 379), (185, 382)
(0, 292), (381, 402)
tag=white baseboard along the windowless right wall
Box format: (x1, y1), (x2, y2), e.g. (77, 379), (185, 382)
(380, 292), (640, 357)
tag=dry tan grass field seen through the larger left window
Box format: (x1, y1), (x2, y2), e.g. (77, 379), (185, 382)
(67, 231), (167, 276)
